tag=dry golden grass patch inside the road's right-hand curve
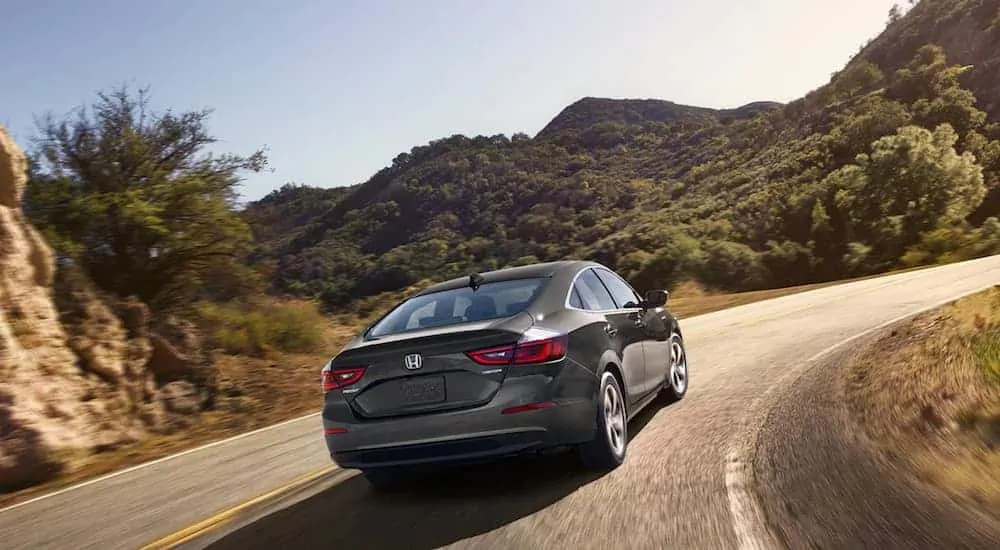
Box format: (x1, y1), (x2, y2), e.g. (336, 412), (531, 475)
(847, 287), (1000, 517)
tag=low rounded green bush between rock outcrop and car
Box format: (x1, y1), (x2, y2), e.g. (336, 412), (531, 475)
(197, 300), (327, 355)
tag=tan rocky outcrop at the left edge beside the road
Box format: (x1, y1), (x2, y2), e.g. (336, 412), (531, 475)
(0, 127), (208, 491)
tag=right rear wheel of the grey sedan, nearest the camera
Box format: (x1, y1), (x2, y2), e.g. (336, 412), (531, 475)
(577, 372), (628, 471)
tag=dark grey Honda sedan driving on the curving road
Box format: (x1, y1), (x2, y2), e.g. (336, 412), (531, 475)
(322, 261), (688, 486)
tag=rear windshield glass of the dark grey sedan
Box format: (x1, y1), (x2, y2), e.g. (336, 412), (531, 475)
(368, 277), (549, 338)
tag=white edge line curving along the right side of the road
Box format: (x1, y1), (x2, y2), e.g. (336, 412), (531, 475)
(726, 283), (997, 550)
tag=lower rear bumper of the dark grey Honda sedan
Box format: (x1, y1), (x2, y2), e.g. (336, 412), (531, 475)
(324, 398), (597, 468)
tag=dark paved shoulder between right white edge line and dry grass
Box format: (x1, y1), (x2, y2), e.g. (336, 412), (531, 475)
(753, 304), (1000, 549)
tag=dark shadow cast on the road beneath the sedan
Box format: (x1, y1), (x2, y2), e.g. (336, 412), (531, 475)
(208, 405), (660, 550)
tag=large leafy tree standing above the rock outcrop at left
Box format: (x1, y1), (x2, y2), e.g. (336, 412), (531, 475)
(26, 87), (267, 309)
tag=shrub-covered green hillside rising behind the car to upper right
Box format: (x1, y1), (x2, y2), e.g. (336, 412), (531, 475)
(245, 0), (1000, 307)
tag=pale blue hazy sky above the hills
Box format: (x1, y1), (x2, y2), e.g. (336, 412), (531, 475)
(0, 0), (905, 200)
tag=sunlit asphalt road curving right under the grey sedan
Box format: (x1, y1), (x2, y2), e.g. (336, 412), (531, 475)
(0, 256), (1000, 550)
